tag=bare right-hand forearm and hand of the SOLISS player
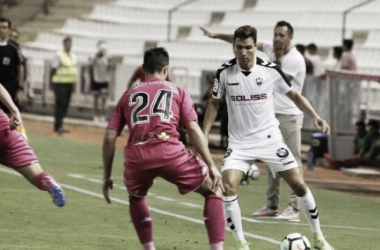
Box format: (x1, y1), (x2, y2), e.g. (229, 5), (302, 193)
(286, 89), (330, 134)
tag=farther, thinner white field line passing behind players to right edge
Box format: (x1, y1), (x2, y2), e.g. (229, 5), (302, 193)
(69, 174), (380, 231)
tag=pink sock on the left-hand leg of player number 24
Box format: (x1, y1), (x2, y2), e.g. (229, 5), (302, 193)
(129, 196), (154, 245)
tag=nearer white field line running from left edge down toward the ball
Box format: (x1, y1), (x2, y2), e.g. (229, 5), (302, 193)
(0, 167), (281, 245)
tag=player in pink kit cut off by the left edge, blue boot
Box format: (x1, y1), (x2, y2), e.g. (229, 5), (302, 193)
(0, 84), (66, 207)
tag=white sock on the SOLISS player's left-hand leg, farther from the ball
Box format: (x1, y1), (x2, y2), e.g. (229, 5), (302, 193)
(223, 195), (244, 241)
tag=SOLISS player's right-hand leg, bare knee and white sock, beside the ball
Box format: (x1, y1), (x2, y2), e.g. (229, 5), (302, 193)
(278, 167), (333, 250)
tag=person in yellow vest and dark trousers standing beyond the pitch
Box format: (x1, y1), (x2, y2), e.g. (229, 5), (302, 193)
(50, 37), (78, 134)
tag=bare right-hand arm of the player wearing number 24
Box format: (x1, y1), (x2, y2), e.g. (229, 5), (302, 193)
(186, 121), (224, 191)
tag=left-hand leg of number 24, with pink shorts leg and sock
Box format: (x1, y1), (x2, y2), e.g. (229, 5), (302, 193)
(124, 168), (157, 250)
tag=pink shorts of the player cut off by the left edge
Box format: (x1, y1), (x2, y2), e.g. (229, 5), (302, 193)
(0, 129), (38, 169)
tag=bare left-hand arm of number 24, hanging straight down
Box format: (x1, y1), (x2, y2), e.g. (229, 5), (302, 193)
(103, 128), (117, 203)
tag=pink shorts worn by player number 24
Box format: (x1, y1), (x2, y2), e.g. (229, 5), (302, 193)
(124, 154), (209, 197)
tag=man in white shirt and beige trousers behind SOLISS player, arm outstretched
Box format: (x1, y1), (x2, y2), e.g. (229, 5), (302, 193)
(201, 21), (306, 221)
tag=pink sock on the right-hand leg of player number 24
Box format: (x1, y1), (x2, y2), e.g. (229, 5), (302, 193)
(203, 196), (226, 244)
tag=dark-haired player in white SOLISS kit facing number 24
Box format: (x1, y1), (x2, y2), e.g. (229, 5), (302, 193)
(203, 26), (333, 250)
